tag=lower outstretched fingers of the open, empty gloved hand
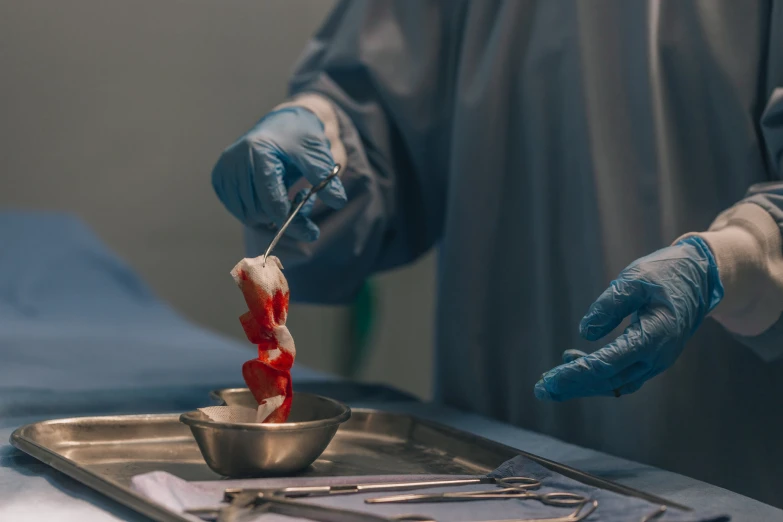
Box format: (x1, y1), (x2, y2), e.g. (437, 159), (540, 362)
(535, 323), (650, 401)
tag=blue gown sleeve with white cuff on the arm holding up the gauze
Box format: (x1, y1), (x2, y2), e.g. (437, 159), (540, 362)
(245, 0), (464, 304)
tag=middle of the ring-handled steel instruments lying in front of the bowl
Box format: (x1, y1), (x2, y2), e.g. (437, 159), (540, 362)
(365, 477), (590, 507)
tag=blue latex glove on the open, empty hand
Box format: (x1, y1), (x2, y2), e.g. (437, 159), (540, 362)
(535, 237), (723, 401)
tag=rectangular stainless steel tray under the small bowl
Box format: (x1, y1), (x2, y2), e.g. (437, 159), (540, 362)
(11, 384), (689, 522)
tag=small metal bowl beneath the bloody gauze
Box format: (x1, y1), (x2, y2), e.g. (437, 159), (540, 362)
(179, 393), (351, 477)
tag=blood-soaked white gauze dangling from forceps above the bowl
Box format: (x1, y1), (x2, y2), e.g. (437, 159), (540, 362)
(231, 256), (296, 423)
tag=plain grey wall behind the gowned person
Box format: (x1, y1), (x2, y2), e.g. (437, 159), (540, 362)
(0, 0), (434, 397)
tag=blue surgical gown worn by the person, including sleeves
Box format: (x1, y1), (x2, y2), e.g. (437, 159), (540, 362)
(246, 0), (783, 506)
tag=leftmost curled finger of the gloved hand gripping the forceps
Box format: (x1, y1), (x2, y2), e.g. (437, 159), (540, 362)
(253, 144), (291, 226)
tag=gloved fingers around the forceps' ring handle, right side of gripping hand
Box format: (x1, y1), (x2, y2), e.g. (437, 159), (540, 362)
(291, 134), (348, 209)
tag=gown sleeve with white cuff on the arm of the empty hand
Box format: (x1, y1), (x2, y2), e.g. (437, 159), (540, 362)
(672, 2), (783, 361)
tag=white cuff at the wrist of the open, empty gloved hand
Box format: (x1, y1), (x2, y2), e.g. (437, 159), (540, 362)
(677, 203), (783, 337)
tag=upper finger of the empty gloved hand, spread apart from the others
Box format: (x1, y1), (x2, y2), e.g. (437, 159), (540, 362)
(579, 272), (651, 341)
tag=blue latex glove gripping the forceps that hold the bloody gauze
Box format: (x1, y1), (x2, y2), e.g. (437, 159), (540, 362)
(212, 107), (347, 241)
